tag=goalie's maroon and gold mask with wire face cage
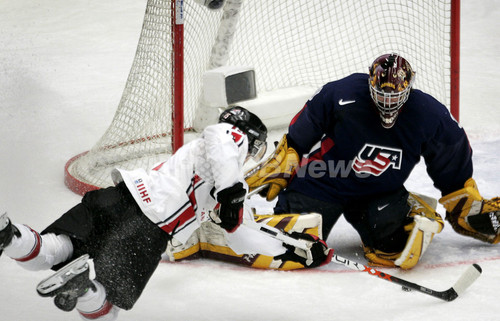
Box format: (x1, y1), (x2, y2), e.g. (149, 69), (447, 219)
(369, 53), (415, 128)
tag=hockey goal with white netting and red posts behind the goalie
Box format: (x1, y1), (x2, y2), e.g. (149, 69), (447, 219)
(65, 0), (460, 194)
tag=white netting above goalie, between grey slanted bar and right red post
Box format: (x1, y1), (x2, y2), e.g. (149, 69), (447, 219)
(228, 0), (450, 103)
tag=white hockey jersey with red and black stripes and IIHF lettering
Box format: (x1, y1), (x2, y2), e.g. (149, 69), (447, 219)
(111, 123), (248, 243)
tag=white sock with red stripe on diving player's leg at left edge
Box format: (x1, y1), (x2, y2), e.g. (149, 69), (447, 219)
(4, 224), (73, 271)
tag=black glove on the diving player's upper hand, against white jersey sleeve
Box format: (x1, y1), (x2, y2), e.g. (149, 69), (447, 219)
(216, 182), (247, 233)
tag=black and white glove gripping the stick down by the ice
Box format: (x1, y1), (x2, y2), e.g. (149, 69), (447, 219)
(274, 232), (333, 268)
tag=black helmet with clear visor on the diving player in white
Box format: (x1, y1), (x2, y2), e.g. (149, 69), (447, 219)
(219, 106), (267, 162)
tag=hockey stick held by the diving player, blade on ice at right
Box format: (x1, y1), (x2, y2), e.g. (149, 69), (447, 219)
(243, 221), (482, 301)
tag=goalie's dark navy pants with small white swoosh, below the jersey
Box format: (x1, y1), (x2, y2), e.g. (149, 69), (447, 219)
(274, 188), (410, 253)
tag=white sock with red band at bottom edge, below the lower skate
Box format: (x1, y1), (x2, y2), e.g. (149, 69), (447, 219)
(76, 280), (120, 321)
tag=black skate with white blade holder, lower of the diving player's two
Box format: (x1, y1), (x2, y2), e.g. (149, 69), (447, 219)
(36, 254), (96, 311)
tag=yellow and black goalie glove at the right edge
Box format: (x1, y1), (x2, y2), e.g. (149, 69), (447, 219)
(439, 178), (500, 244)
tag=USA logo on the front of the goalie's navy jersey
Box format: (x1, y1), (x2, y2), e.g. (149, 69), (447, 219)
(352, 144), (403, 176)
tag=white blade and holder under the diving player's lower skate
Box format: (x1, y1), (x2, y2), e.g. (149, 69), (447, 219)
(36, 254), (89, 296)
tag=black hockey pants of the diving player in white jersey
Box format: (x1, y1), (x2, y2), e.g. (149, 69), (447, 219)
(42, 183), (170, 310)
